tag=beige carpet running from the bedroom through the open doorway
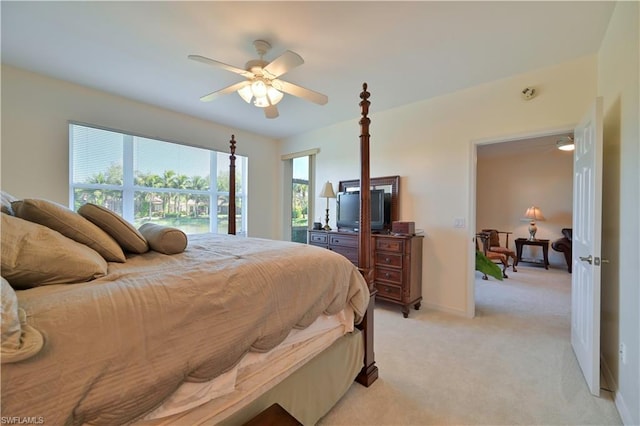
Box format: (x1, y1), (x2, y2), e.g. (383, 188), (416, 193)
(319, 265), (621, 425)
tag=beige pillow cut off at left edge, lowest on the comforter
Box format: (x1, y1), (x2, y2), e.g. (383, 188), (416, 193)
(0, 277), (44, 364)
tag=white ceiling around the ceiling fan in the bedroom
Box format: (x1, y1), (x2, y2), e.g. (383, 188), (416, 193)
(0, 1), (614, 138)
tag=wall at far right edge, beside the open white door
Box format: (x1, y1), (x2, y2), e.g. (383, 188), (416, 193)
(598, 2), (640, 425)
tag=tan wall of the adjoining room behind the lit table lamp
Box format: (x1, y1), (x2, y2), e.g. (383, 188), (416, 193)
(476, 145), (573, 270)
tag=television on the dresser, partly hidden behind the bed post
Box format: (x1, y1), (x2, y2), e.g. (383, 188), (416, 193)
(336, 189), (391, 232)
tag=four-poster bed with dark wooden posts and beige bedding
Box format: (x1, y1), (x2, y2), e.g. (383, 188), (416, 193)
(1, 84), (378, 425)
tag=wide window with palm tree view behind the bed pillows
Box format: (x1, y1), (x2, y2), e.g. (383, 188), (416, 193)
(69, 123), (247, 235)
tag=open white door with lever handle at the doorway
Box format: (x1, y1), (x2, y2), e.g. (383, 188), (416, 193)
(571, 98), (602, 395)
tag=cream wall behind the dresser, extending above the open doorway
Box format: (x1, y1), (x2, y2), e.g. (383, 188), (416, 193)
(281, 56), (596, 315)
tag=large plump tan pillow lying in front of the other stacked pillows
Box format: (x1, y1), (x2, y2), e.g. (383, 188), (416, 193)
(1, 213), (107, 289)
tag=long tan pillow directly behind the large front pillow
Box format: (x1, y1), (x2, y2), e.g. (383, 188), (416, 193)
(11, 198), (126, 262)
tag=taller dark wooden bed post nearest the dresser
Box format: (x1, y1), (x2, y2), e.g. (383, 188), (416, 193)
(356, 83), (378, 387)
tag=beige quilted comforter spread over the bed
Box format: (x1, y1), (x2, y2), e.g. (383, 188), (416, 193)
(1, 234), (369, 425)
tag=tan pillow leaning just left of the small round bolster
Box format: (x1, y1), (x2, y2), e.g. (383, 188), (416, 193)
(78, 203), (149, 254)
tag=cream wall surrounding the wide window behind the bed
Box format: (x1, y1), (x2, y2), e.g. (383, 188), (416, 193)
(1, 65), (280, 238)
